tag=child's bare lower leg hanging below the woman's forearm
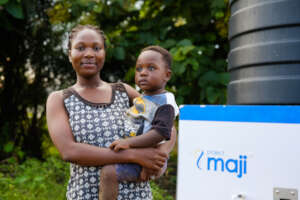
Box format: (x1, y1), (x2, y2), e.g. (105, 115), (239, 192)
(99, 165), (119, 200)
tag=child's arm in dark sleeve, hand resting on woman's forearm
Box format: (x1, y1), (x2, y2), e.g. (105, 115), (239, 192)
(110, 104), (174, 151)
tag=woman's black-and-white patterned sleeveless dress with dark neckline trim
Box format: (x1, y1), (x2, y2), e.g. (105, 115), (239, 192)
(63, 83), (152, 200)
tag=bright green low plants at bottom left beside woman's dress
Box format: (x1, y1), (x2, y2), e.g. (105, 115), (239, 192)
(0, 157), (69, 200)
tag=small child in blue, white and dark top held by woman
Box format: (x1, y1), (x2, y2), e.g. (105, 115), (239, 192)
(99, 46), (179, 200)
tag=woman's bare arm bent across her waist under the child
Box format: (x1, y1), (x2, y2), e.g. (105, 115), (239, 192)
(46, 91), (167, 170)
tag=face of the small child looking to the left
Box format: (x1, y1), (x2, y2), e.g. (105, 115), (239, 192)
(135, 50), (171, 95)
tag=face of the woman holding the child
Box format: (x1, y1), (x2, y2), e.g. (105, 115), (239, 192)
(69, 29), (105, 78)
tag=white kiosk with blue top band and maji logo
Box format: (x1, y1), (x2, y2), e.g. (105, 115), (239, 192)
(177, 105), (300, 200)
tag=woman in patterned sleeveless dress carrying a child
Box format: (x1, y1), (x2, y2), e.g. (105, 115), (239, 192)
(47, 25), (175, 200)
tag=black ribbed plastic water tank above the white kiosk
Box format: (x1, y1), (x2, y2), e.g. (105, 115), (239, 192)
(228, 0), (300, 104)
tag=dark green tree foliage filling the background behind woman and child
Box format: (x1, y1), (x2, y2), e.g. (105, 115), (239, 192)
(0, 0), (229, 177)
